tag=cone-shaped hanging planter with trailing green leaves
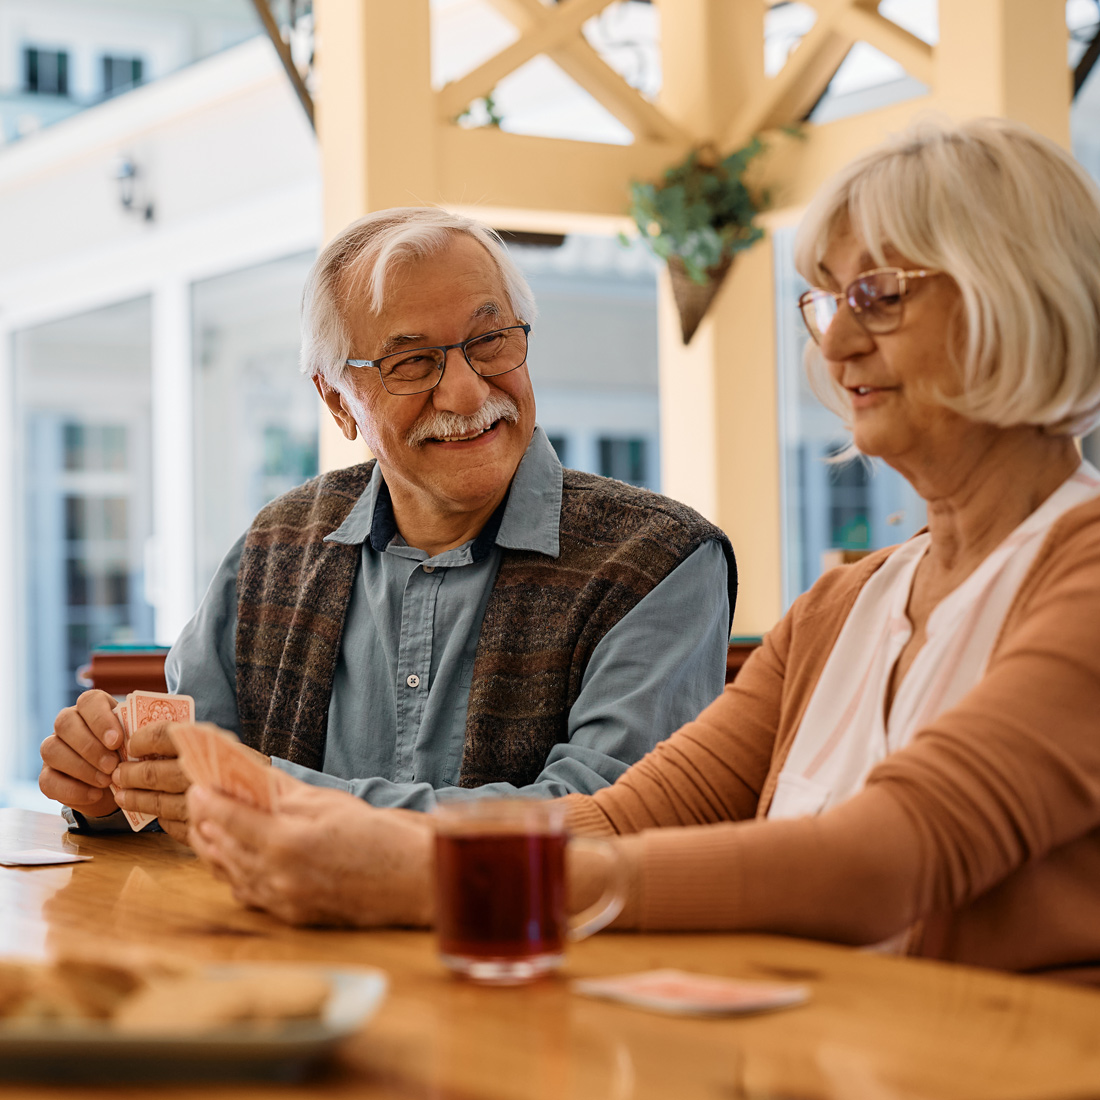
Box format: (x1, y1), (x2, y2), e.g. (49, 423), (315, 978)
(630, 138), (768, 344)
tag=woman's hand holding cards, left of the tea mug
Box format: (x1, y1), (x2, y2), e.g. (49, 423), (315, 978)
(187, 774), (435, 927)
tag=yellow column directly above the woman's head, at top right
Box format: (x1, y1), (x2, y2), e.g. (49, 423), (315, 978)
(935, 0), (1073, 149)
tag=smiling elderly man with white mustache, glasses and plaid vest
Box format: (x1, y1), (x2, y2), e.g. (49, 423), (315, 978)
(40, 209), (736, 837)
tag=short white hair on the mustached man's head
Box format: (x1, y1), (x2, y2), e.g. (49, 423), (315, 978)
(299, 207), (537, 392)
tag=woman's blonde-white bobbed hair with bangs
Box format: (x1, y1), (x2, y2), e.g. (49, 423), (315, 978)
(794, 119), (1100, 436)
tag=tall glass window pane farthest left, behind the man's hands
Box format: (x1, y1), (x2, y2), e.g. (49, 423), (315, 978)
(13, 298), (153, 779)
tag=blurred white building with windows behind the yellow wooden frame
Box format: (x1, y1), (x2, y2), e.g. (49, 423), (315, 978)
(0, 0), (1100, 803)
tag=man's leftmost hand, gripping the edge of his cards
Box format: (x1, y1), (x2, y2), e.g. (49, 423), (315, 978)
(39, 691), (122, 817)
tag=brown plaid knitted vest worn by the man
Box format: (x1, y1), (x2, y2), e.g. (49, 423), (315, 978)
(237, 462), (737, 787)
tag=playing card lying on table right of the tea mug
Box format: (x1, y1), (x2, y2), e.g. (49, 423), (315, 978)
(572, 970), (810, 1016)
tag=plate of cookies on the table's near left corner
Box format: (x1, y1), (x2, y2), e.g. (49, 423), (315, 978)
(0, 956), (387, 1084)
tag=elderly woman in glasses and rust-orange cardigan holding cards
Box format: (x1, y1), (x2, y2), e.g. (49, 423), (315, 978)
(184, 121), (1100, 975)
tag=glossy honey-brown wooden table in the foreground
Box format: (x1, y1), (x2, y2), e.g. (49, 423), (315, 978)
(0, 810), (1100, 1100)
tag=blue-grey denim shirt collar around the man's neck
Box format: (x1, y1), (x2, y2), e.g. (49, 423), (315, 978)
(325, 426), (561, 561)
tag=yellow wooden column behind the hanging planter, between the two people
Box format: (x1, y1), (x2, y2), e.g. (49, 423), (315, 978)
(658, 0), (782, 634)
